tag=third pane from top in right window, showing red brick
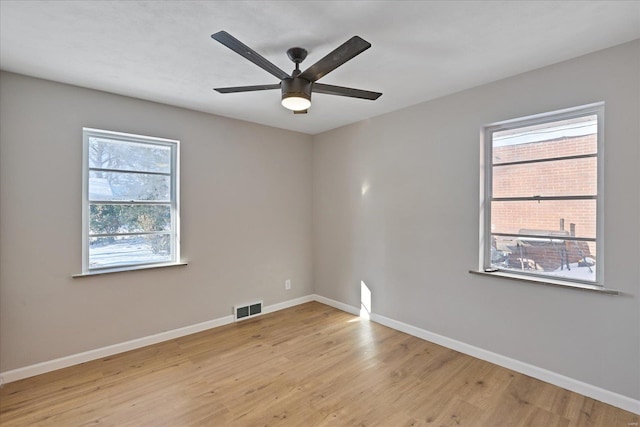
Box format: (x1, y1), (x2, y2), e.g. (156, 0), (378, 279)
(491, 200), (596, 238)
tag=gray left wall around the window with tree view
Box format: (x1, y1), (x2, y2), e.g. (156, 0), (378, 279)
(0, 72), (313, 372)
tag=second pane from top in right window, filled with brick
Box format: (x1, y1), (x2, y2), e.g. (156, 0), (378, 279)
(493, 157), (598, 197)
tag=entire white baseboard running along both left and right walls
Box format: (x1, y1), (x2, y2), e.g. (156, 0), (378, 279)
(0, 294), (640, 414)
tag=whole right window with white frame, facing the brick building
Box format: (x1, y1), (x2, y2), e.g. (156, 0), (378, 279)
(481, 103), (604, 286)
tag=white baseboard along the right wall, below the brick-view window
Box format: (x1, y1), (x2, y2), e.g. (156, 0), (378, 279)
(315, 295), (640, 415)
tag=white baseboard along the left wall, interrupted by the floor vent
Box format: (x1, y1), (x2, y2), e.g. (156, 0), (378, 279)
(0, 295), (315, 385)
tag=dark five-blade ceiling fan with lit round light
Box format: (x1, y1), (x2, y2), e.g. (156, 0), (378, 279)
(211, 31), (382, 114)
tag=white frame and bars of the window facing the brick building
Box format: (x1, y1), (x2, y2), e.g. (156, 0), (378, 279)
(479, 102), (604, 289)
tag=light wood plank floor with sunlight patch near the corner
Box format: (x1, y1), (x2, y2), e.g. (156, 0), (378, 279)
(0, 302), (639, 427)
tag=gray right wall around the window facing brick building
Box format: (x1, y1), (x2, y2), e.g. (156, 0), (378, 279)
(313, 41), (640, 399)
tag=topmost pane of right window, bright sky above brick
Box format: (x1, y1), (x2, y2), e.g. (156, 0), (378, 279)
(492, 114), (598, 165)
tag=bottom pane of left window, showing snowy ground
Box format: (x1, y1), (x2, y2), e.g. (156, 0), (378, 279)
(89, 234), (171, 268)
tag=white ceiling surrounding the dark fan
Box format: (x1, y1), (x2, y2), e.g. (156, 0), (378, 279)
(0, 0), (640, 134)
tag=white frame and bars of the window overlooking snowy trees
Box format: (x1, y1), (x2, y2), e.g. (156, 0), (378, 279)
(81, 127), (180, 277)
